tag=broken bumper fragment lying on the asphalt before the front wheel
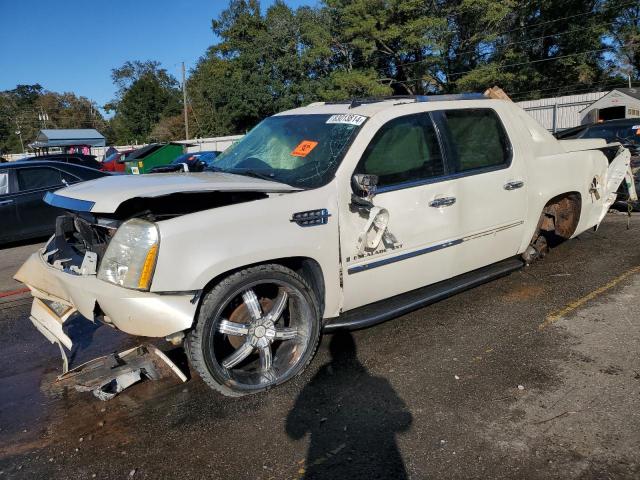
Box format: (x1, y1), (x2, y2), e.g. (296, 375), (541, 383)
(58, 344), (187, 401)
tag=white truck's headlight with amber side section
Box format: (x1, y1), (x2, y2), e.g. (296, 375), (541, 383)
(98, 218), (160, 290)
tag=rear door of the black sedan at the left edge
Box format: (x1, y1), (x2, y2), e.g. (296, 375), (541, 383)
(15, 167), (69, 237)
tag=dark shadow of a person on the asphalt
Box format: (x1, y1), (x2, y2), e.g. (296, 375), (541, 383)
(286, 332), (412, 479)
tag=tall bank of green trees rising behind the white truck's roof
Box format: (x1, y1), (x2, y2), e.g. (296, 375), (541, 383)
(189, 0), (628, 135)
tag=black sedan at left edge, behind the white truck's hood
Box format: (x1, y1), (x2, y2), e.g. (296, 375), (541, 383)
(0, 160), (109, 243)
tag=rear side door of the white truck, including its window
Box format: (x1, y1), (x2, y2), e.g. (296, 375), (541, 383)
(433, 108), (527, 274)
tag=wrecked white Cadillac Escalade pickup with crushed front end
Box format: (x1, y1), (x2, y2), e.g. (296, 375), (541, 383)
(16, 95), (629, 396)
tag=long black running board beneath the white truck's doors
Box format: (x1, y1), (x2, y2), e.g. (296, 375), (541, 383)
(323, 257), (524, 333)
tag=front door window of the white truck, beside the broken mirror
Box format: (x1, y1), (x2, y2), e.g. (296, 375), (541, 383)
(357, 113), (444, 187)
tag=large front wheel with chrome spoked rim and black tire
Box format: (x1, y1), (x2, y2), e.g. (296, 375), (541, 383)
(185, 264), (321, 397)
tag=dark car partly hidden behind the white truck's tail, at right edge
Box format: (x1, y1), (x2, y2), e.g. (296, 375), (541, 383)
(555, 118), (640, 161)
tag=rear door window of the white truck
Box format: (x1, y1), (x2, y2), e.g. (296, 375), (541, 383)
(444, 109), (511, 172)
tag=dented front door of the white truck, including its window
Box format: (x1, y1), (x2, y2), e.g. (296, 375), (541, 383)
(340, 112), (462, 311)
